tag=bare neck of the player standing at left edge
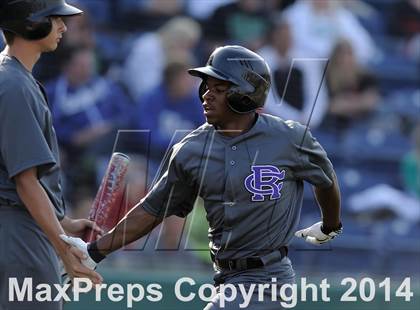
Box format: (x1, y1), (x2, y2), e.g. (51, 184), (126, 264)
(5, 40), (41, 72)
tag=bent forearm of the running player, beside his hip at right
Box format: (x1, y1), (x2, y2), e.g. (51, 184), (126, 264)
(314, 174), (341, 229)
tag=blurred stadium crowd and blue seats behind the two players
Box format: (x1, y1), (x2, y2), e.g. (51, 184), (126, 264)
(2, 0), (420, 310)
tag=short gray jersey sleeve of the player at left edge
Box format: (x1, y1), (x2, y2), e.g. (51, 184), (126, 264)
(0, 85), (56, 178)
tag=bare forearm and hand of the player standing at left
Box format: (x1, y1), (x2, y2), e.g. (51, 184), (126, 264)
(14, 167), (102, 283)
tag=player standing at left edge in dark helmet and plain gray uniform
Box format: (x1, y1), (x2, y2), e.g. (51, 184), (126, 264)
(0, 0), (101, 310)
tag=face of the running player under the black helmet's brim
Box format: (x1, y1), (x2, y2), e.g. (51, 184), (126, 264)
(203, 77), (234, 128)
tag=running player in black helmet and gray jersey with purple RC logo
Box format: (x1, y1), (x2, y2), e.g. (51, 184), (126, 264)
(64, 46), (341, 310)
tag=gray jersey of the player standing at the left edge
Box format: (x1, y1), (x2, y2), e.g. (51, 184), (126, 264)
(0, 54), (64, 219)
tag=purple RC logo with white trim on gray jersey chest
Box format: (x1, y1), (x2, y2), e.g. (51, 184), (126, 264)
(244, 165), (286, 201)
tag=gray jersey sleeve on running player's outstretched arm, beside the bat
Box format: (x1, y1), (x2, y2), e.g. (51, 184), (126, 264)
(141, 145), (198, 218)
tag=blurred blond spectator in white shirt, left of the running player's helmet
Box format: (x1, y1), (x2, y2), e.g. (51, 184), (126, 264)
(122, 17), (201, 100)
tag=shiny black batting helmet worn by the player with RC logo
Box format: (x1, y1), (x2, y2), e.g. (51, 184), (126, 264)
(188, 45), (271, 114)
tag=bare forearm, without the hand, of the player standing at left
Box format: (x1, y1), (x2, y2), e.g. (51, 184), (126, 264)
(15, 168), (67, 254)
